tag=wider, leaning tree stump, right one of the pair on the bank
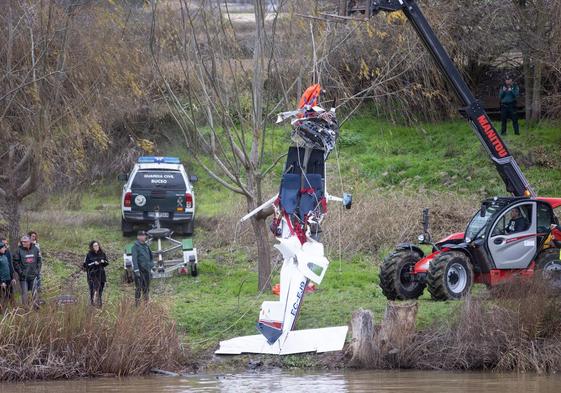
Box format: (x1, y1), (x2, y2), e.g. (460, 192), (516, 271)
(376, 301), (419, 355)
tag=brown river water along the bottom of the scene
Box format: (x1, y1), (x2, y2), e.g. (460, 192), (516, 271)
(0, 371), (561, 393)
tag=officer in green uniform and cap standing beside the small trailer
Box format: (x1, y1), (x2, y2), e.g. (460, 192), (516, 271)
(132, 231), (154, 306)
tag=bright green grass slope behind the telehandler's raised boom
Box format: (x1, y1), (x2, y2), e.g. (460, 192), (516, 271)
(340, 117), (561, 195)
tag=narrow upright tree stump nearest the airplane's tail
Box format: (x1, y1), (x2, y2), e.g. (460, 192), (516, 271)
(350, 308), (377, 368)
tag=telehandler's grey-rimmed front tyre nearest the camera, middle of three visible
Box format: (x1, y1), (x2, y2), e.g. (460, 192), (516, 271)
(427, 251), (473, 300)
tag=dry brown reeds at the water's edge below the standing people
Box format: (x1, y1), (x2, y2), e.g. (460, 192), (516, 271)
(0, 300), (186, 381)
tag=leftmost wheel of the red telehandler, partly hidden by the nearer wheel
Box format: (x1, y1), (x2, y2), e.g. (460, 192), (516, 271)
(380, 250), (425, 300)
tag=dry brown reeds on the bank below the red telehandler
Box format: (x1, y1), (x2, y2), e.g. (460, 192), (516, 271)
(392, 280), (561, 373)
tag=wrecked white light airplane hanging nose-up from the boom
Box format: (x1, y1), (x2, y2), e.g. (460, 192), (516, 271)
(215, 85), (352, 355)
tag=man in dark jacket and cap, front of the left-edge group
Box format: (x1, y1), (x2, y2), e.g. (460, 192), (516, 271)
(13, 235), (41, 305)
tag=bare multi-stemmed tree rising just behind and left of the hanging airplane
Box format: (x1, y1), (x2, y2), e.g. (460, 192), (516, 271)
(151, 0), (284, 289)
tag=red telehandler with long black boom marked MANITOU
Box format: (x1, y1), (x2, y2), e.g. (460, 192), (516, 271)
(344, 0), (561, 300)
